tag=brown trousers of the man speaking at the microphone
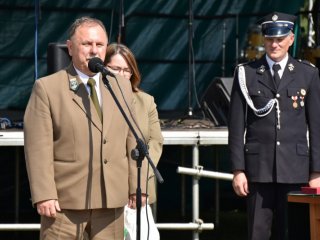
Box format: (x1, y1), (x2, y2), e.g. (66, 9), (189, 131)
(40, 208), (124, 240)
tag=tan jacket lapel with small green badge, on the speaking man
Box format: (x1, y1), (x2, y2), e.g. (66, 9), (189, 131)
(67, 64), (102, 131)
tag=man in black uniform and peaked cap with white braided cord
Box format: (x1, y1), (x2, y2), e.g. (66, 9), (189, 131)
(229, 12), (320, 240)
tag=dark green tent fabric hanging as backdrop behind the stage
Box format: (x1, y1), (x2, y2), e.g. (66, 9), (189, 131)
(0, 0), (303, 111)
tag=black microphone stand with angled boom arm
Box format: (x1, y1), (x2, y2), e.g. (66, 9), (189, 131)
(102, 74), (163, 240)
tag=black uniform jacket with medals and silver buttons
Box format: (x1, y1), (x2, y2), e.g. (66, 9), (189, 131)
(228, 55), (320, 183)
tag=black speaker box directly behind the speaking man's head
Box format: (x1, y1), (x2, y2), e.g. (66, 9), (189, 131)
(47, 43), (71, 74)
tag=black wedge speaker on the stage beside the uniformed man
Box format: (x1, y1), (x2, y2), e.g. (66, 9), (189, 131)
(201, 77), (233, 126)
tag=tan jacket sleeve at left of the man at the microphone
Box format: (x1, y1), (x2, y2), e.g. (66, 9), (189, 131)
(24, 80), (58, 204)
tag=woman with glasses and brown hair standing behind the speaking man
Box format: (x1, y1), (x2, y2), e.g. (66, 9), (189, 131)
(105, 43), (163, 212)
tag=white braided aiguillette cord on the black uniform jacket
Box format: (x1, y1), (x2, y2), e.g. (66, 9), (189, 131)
(238, 66), (280, 129)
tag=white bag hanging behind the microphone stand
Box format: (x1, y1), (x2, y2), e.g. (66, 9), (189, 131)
(124, 204), (160, 240)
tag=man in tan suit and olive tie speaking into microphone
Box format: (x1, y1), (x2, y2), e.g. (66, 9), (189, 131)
(24, 17), (146, 240)
